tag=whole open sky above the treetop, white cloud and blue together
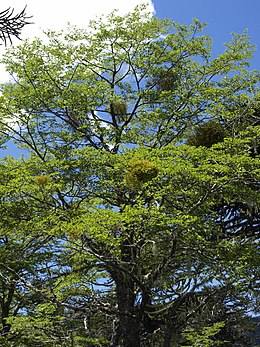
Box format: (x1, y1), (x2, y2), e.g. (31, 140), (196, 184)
(0, 0), (260, 156)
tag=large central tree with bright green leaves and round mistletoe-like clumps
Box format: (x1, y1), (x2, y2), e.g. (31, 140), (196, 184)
(0, 7), (260, 347)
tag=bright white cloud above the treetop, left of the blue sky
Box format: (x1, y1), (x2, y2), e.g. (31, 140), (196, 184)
(0, 0), (154, 82)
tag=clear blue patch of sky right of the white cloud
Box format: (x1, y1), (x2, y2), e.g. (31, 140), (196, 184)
(153, 0), (260, 69)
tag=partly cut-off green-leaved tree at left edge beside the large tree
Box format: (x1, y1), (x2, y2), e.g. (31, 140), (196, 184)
(0, 158), (66, 346)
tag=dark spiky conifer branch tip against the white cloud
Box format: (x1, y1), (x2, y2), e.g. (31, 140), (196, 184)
(0, 7), (31, 45)
